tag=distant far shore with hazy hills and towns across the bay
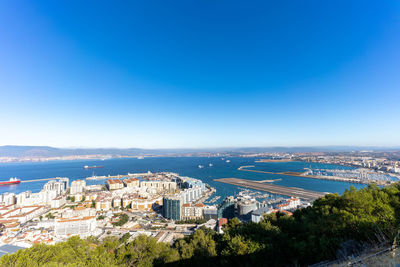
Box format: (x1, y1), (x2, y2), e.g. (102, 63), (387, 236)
(0, 146), (400, 163)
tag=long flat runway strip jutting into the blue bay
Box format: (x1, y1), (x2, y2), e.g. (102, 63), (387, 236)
(214, 178), (328, 202)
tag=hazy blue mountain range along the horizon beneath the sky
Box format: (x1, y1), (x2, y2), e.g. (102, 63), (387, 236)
(0, 146), (400, 158)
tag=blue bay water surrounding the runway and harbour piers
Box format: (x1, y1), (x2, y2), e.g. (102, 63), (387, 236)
(0, 157), (363, 201)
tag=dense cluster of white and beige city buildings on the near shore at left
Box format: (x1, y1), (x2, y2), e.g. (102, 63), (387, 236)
(0, 173), (211, 250)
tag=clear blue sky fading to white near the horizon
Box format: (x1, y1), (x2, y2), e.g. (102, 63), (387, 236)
(0, 0), (400, 148)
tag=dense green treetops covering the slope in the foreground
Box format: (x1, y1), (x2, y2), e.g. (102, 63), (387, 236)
(0, 184), (400, 266)
